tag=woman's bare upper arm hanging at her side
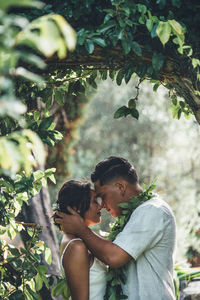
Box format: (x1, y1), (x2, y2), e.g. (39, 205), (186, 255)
(62, 241), (89, 300)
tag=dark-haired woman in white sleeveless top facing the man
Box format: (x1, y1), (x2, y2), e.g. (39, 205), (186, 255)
(54, 180), (106, 300)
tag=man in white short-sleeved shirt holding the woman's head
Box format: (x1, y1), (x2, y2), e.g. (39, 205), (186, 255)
(57, 156), (175, 300)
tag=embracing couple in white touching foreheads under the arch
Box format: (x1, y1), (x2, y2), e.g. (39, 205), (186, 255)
(54, 156), (175, 300)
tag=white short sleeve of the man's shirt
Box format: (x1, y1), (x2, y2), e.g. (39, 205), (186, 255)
(113, 205), (164, 260)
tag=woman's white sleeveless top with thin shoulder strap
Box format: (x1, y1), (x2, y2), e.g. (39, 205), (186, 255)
(60, 238), (107, 300)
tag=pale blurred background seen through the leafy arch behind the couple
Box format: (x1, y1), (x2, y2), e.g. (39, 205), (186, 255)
(48, 78), (200, 266)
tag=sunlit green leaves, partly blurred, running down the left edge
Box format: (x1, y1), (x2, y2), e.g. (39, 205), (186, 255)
(0, 0), (76, 300)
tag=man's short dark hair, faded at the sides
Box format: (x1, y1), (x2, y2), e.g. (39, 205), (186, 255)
(91, 156), (139, 185)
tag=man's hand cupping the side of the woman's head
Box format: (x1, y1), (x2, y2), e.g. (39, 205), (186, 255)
(55, 206), (86, 236)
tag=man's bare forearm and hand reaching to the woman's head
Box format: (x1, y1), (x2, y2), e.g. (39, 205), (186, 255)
(55, 208), (132, 268)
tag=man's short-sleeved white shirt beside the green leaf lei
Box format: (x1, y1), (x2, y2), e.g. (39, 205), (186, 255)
(114, 196), (176, 300)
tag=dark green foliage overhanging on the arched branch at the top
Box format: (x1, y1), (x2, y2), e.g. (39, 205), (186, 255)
(35, 0), (200, 122)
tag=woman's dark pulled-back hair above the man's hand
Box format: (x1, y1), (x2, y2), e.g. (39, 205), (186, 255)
(53, 180), (91, 228)
